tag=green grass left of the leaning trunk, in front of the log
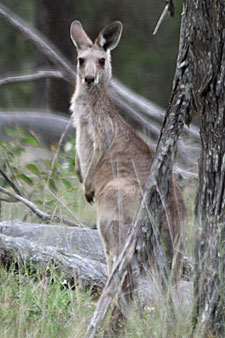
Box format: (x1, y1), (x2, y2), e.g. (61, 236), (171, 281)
(0, 266), (94, 338)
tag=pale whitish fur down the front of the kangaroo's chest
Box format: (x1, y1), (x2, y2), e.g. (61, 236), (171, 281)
(71, 97), (94, 178)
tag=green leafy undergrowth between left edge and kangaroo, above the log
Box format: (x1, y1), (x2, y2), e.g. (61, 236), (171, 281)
(0, 129), (95, 224)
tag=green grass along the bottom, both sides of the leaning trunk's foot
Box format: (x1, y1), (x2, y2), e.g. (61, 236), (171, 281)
(0, 265), (195, 338)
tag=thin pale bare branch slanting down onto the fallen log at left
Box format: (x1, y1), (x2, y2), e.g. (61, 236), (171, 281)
(0, 186), (78, 226)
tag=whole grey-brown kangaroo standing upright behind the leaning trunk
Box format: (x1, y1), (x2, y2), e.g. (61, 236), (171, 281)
(71, 21), (185, 273)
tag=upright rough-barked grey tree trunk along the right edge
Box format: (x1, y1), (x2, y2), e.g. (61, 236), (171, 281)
(184, 0), (225, 337)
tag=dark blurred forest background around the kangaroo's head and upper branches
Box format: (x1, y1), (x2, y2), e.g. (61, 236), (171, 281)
(0, 0), (181, 113)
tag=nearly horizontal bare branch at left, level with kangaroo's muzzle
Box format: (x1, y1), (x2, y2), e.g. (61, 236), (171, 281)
(0, 70), (64, 86)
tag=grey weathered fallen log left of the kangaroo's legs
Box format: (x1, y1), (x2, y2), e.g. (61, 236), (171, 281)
(0, 222), (107, 290)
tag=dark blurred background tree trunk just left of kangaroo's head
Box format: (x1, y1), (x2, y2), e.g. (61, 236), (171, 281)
(35, 0), (75, 113)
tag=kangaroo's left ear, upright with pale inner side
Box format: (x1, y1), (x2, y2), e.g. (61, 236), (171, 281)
(70, 21), (93, 49)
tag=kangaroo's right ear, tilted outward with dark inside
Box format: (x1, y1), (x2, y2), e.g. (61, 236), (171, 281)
(95, 21), (123, 51)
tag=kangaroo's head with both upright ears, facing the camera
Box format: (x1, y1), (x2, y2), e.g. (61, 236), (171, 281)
(70, 21), (122, 88)
